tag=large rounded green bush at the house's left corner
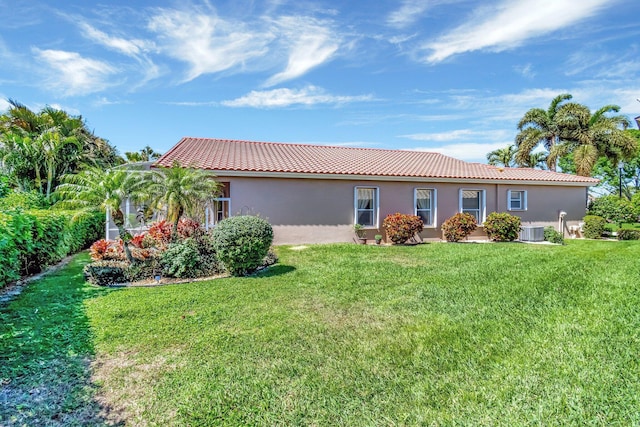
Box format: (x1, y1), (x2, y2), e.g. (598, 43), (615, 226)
(213, 215), (273, 276)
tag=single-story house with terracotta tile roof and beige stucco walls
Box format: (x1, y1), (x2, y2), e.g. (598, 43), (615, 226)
(153, 138), (598, 244)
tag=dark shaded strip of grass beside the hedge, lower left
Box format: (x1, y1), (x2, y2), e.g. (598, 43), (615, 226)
(0, 254), (124, 426)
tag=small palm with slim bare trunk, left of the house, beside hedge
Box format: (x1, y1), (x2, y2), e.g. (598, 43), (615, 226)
(56, 167), (144, 262)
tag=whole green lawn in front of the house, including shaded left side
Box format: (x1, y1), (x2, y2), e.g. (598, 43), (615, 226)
(0, 240), (640, 426)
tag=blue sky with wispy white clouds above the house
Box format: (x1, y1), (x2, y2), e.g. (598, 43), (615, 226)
(0, 0), (640, 162)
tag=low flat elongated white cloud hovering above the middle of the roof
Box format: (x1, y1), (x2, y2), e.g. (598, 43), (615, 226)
(222, 86), (373, 108)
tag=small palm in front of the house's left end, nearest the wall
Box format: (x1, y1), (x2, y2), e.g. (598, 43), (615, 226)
(145, 162), (220, 239)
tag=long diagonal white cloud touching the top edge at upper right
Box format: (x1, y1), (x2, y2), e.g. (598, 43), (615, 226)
(423, 0), (611, 63)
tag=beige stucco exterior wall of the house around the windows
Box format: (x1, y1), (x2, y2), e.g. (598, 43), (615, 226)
(216, 175), (587, 244)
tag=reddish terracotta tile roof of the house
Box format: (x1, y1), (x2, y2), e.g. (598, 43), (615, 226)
(154, 137), (598, 186)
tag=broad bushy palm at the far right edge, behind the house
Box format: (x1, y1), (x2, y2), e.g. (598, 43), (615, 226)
(559, 104), (638, 176)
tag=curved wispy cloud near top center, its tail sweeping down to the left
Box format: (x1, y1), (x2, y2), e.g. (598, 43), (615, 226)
(265, 17), (340, 86)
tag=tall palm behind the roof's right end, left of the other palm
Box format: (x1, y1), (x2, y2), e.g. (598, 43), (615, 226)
(515, 93), (572, 171)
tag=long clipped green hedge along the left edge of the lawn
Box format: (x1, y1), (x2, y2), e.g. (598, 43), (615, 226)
(0, 208), (104, 287)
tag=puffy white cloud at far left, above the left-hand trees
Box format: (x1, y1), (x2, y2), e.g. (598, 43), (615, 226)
(32, 48), (117, 96)
